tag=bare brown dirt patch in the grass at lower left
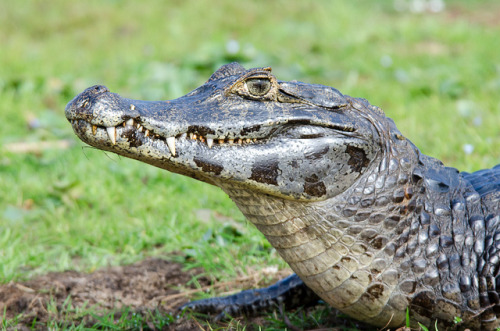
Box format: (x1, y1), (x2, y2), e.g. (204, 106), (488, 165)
(0, 258), (210, 330)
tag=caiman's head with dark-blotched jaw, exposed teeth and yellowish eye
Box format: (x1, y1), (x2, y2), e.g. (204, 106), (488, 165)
(65, 63), (394, 201)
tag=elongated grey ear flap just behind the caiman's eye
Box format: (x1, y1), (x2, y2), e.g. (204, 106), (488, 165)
(279, 82), (347, 109)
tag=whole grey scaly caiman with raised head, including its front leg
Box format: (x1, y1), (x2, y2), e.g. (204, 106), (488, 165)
(65, 63), (500, 330)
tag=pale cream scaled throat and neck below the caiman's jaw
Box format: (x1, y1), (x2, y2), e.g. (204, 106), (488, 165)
(218, 137), (426, 323)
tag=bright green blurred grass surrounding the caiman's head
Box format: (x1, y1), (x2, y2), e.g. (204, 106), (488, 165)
(0, 0), (500, 330)
